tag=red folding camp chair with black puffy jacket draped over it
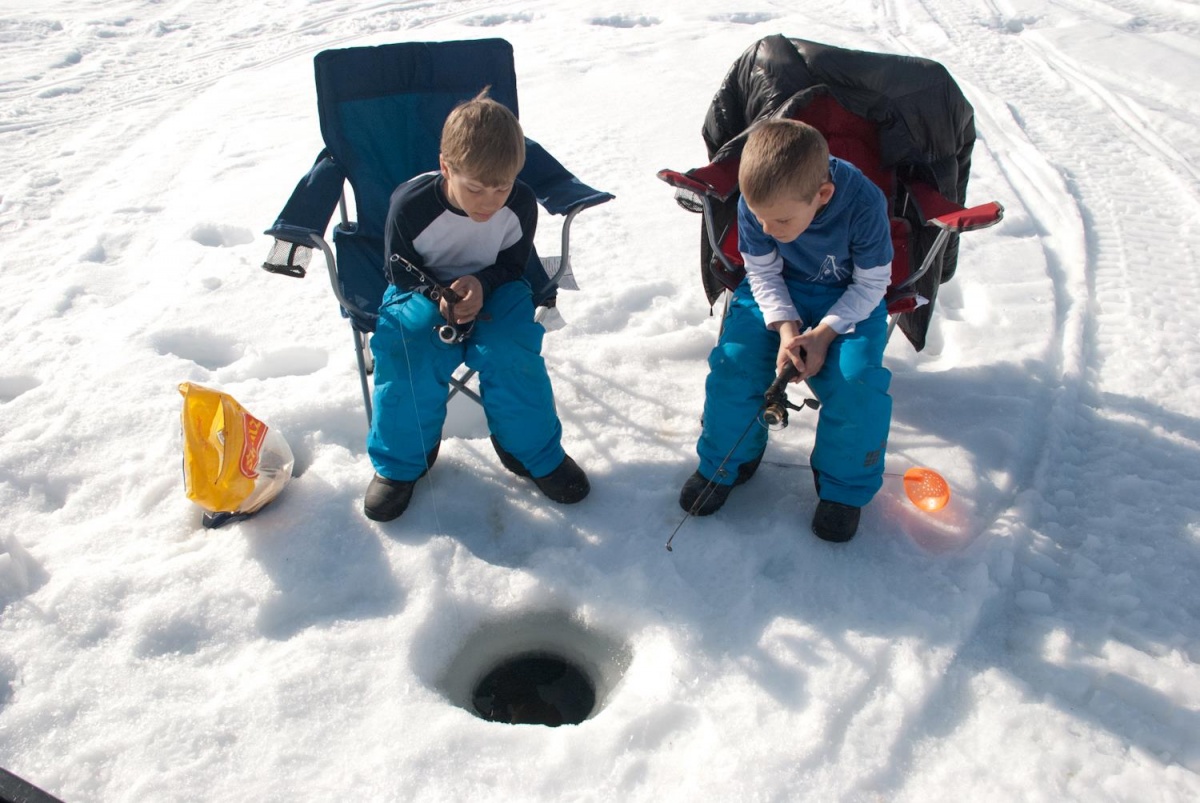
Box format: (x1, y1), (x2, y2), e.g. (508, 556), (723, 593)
(658, 36), (1004, 350)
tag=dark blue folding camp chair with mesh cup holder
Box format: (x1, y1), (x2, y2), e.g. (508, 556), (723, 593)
(263, 38), (613, 423)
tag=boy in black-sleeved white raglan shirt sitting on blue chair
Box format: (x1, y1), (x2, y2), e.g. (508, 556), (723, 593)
(364, 90), (589, 521)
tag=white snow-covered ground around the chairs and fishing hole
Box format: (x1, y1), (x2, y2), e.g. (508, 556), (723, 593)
(0, 0), (1200, 801)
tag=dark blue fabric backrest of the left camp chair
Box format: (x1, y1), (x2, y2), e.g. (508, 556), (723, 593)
(314, 40), (518, 331)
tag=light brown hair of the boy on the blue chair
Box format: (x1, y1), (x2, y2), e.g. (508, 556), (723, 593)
(442, 88), (524, 187)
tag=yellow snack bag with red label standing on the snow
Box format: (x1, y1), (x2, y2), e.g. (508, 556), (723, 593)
(179, 382), (295, 527)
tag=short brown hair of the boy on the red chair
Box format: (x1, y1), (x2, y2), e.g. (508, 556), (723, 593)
(738, 120), (829, 204)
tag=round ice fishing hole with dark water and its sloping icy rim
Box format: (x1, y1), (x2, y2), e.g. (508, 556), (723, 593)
(438, 612), (630, 727)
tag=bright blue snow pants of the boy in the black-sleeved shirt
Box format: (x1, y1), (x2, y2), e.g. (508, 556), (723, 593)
(367, 282), (564, 480)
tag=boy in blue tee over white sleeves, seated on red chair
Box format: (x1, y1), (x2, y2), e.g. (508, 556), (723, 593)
(679, 120), (892, 541)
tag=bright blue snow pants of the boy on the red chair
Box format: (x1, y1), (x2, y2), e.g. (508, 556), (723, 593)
(696, 281), (892, 508)
